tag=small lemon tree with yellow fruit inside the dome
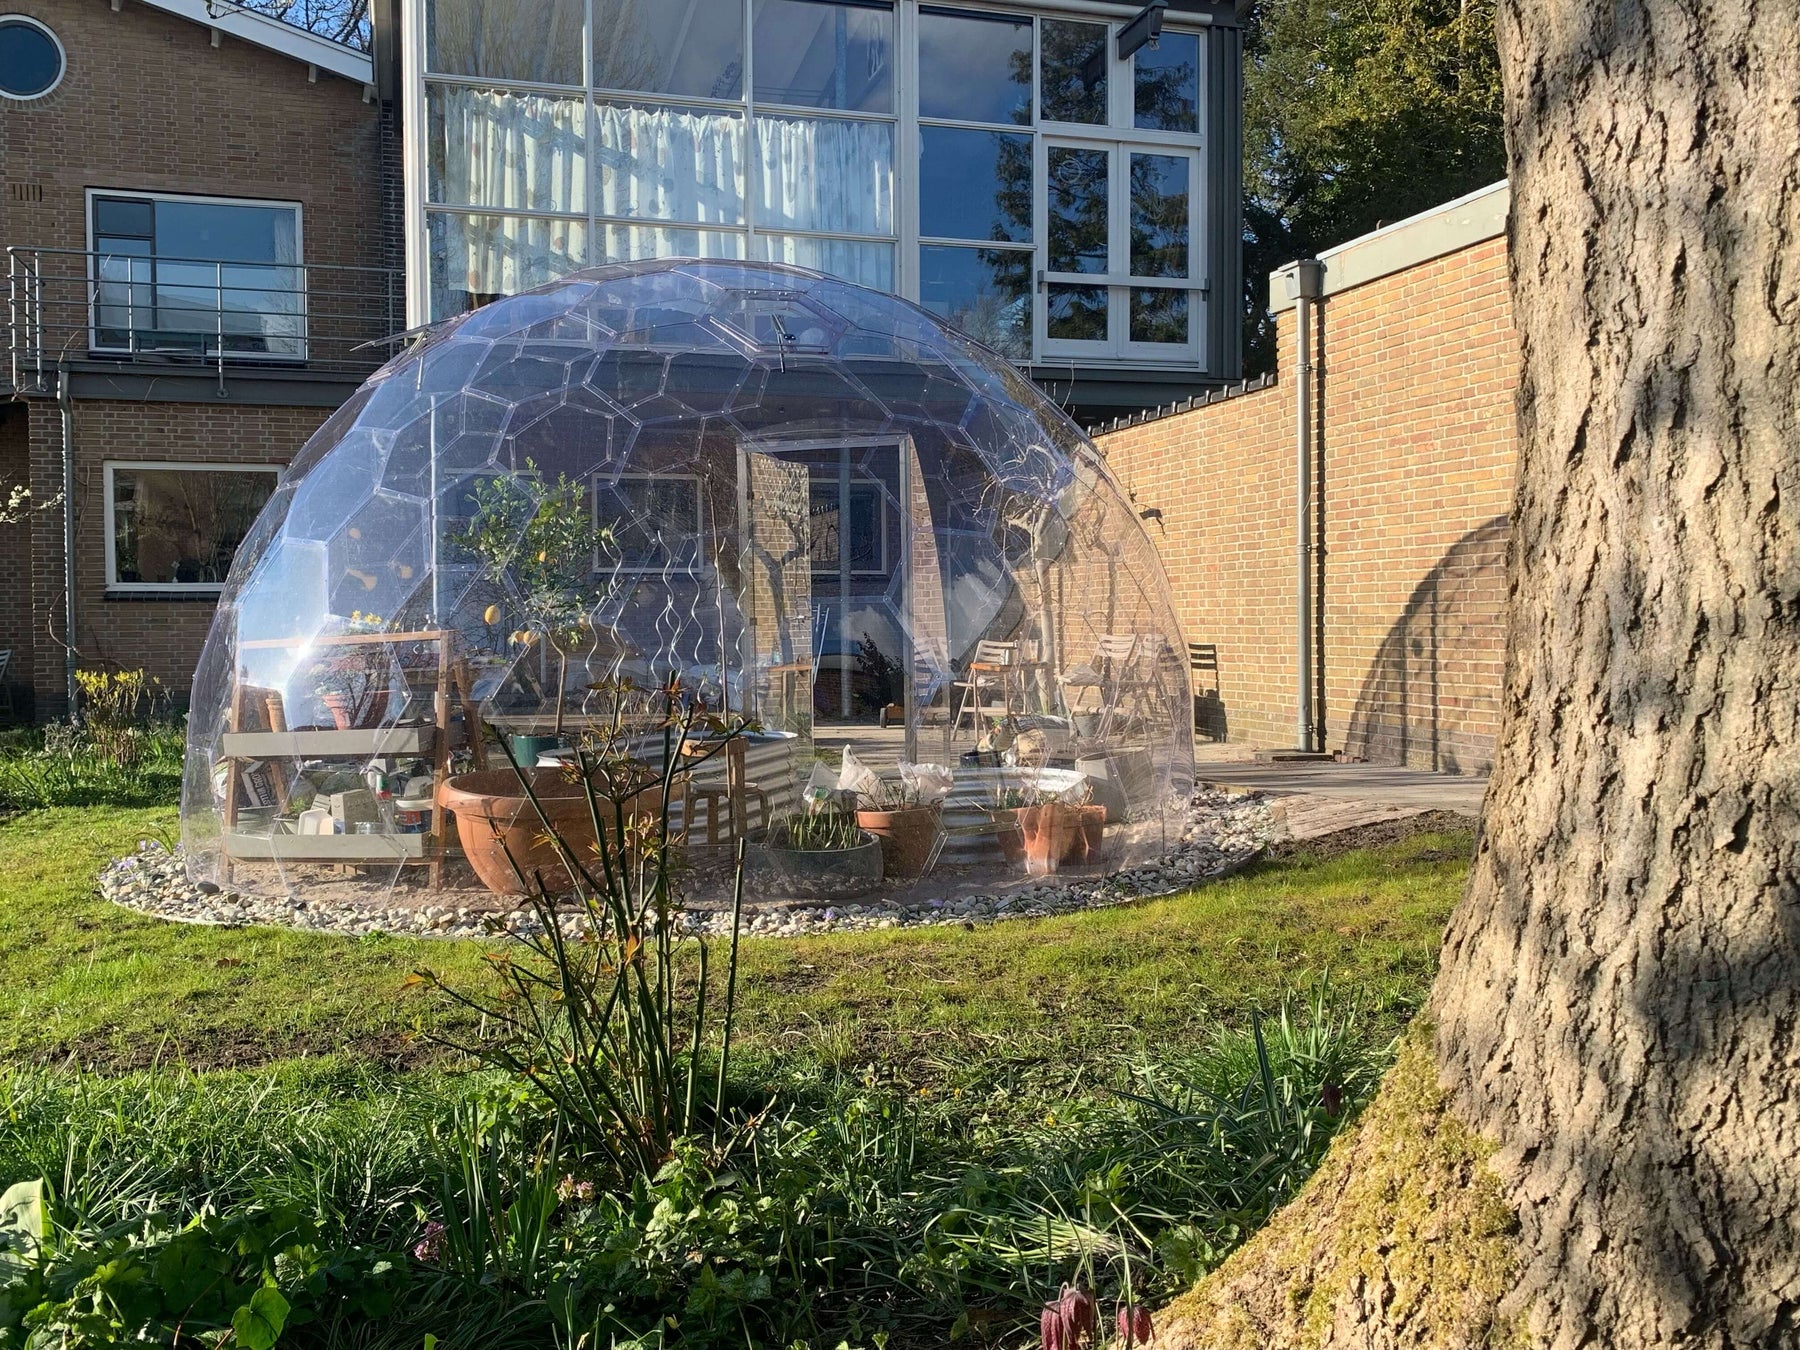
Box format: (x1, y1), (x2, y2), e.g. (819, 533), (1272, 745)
(450, 459), (614, 767)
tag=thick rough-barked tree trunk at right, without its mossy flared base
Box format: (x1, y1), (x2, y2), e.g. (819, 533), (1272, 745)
(1433, 0), (1800, 1346)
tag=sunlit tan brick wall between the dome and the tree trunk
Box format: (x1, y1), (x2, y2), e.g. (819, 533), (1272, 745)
(1098, 238), (1517, 772)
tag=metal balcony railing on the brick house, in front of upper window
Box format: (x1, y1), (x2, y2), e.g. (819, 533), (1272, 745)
(5, 247), (407, 392)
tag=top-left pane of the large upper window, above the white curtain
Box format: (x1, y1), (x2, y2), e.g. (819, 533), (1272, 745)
(425, 0), (583, 85)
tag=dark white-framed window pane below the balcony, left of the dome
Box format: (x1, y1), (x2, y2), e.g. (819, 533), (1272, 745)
(106, 466), (275, 585)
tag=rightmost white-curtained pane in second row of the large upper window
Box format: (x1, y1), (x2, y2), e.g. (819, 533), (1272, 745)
(754, 117), (895, 234)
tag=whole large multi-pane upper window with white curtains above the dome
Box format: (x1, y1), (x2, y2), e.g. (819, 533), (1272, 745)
(412, 0), (1208, 365)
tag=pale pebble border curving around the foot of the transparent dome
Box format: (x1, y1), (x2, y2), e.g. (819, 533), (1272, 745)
(99, 788), (1280, 938)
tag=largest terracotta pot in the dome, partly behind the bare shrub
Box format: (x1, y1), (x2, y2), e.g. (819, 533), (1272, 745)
(437, 769), (662, 895)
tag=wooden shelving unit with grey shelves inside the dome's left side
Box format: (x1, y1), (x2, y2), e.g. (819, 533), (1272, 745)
(221, 628), (482, 887)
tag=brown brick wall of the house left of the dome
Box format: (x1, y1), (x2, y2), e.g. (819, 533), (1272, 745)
(0, 0), (383, 715)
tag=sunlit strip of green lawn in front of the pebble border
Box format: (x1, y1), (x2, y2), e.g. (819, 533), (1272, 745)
(0, 808), (1469, 1082)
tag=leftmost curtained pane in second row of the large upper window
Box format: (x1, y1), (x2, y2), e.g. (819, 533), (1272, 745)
(425, 85), (589, 212)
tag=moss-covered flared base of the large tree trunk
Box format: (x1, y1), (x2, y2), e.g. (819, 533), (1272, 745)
(1156, 1024), (1523, 1350)
